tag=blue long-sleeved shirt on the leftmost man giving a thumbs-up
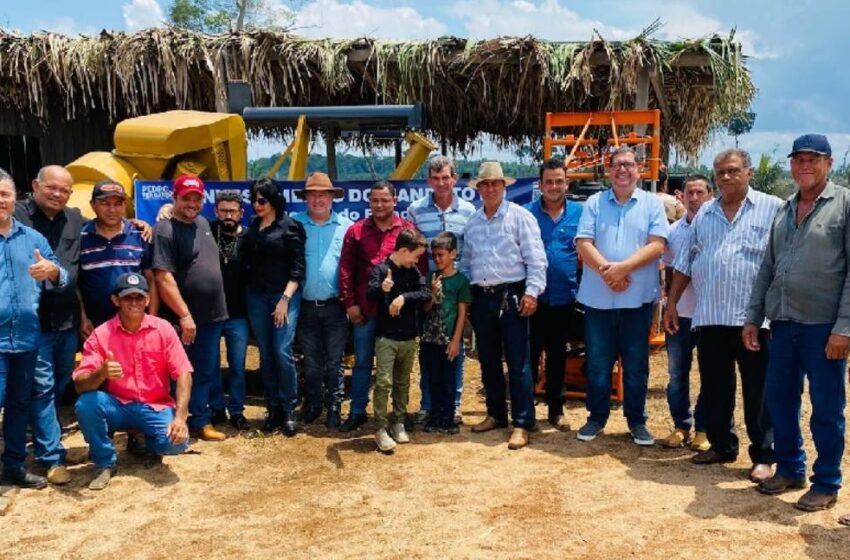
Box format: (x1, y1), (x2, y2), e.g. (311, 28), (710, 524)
(0, 218), (68, 353)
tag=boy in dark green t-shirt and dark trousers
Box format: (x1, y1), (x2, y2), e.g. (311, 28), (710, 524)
(419, 231), (472, 434)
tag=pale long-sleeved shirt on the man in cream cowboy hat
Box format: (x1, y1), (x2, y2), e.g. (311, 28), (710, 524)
(460, 199), (547, 297)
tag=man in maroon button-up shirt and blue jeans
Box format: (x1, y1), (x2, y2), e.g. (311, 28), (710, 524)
(339, 181), (424, 432)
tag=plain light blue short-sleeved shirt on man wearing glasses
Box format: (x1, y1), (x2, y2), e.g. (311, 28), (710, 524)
(576, 188), (668, 309)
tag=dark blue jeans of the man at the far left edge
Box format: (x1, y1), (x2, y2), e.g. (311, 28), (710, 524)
(0, 350), (38, 472)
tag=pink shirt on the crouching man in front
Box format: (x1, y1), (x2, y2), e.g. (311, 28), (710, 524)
(74, 315), (192, 411)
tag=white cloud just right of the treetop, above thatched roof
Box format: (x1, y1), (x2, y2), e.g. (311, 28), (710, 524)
(294, 0), (446, 39)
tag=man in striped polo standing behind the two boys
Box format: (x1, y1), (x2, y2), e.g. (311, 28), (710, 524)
(407, 156), (475, 422)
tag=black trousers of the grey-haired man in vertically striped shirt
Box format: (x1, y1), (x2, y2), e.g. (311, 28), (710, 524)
(697, 326), (773, 464)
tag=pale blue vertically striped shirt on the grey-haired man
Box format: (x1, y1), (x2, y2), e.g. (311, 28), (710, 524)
(673, 188), (782, 327)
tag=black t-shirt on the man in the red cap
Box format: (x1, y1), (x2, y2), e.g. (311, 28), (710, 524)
(153, 216), (227, 325)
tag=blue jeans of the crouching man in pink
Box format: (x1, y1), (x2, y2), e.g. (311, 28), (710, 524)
(76, 391), (189, 469)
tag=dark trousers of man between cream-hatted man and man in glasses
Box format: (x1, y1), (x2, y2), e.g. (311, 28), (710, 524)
(530, 303), (574, 418)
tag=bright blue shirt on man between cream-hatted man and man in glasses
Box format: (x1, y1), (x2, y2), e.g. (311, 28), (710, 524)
(525, 198), (581, 305)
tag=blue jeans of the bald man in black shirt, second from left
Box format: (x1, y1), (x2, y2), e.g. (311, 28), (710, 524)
(30, 327), (79, 467)
